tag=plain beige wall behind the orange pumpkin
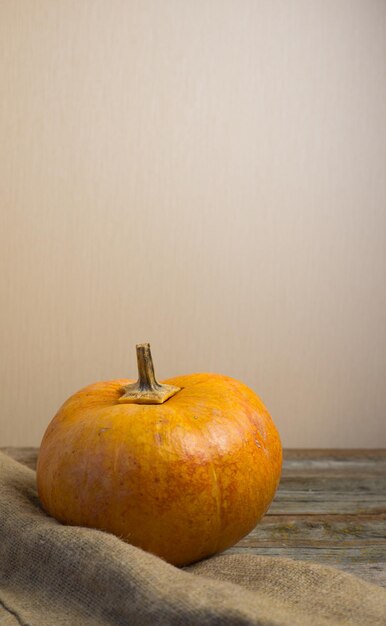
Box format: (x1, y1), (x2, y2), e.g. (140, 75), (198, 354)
(0, 0), (386, 447)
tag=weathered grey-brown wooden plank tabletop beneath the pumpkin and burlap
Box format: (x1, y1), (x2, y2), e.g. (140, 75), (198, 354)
(2, 448), (386, 587)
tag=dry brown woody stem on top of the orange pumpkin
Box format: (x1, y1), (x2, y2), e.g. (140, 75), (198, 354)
(118, 343), (180, 404)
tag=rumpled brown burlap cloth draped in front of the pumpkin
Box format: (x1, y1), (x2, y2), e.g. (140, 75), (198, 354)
(0, 453), (386, 626)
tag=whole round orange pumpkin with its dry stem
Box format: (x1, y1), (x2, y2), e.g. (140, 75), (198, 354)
(37, 344), (282, 565)
